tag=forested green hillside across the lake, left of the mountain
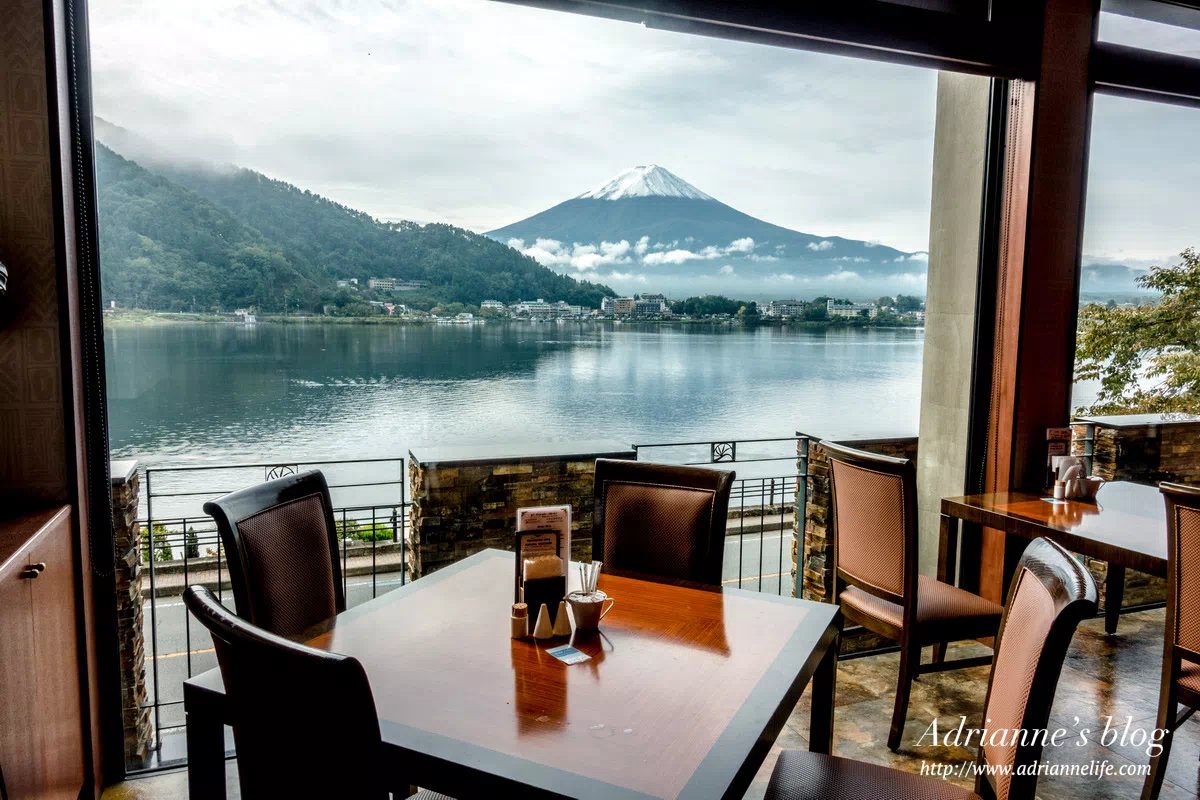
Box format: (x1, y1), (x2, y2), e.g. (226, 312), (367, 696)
(96, 145), (614, 314)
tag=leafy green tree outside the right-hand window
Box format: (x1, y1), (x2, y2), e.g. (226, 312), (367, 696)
(1075, 247), (1200, 414)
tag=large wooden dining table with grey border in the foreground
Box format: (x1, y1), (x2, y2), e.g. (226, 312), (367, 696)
(184, 551), (840, 800)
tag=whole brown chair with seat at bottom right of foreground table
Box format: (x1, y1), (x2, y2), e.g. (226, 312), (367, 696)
(767, 539), (1096, 800)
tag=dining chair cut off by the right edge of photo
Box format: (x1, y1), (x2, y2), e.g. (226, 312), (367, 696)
(1141, 483), (1200, 800)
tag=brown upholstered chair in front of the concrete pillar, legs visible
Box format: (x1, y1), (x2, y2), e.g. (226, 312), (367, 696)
(821, 441), (1004, 750)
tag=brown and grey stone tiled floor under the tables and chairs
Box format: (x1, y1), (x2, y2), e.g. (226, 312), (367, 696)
(104, 610), (1200, 800)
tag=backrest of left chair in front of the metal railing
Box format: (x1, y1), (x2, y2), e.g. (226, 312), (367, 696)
(204, 470), (346, 636)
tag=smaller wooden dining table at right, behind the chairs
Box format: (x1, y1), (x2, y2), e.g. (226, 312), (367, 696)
(938, 481), (1166, 633)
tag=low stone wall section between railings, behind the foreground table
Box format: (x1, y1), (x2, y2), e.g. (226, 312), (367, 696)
(406, 443), (636, 578)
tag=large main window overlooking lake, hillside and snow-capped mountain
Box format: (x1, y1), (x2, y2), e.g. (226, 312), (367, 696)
(90, 0), (945, 766)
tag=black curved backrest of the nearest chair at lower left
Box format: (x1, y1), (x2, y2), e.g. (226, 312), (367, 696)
(184, 587), (388, 800)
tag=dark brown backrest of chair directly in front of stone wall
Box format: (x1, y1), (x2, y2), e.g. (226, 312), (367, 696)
(592, 458), (734, 587)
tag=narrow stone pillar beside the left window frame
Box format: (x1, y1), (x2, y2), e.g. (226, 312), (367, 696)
(112, 461), (154, 769)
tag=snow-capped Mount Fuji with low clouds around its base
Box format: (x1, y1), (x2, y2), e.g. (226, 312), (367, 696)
(486, 164), (928, 299)
